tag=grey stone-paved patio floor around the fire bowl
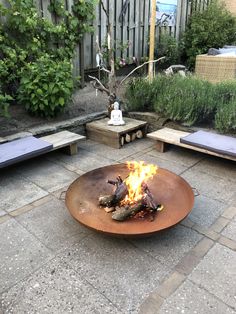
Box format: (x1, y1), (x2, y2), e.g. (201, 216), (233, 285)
(0, 139), (236, 314)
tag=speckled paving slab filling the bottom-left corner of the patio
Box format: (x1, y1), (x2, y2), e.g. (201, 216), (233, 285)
(1, 259), (122, 314)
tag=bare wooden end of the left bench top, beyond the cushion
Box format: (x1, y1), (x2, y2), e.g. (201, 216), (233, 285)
(40, 131), (85, 150)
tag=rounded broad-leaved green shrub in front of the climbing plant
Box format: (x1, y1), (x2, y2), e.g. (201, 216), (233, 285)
(18, 56), (73, 117)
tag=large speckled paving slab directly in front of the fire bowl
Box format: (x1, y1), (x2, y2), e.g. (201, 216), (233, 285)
(59, 233), (169, 313)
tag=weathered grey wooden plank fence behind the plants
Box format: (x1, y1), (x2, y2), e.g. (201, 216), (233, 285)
(0, 0), (211, 75)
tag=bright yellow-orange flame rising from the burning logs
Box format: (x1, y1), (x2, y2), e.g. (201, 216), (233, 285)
(124, 161), (158, 204)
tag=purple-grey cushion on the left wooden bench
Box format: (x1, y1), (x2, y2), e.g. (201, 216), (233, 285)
(0, 136), (53, 168)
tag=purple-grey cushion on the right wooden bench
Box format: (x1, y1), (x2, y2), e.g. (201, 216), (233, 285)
(180, 131), (236, 157)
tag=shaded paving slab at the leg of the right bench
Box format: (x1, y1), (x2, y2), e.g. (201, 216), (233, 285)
(148, 146), (206, 167)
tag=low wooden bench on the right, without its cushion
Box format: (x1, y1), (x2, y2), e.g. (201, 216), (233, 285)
(147, 128), (236, 161)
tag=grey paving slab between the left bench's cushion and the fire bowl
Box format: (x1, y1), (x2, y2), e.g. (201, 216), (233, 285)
(17, 157), (78, 192)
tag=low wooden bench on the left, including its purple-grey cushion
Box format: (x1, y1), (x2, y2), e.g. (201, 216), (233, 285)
(0, 131), (85, 168)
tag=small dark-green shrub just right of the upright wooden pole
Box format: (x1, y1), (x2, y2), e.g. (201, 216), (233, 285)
(155, 34), (180, 67)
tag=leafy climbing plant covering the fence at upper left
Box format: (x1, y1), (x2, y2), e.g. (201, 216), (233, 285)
(0, 0), (95, 116)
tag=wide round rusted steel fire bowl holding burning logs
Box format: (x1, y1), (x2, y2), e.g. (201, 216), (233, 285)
(66, 164), (194, 237)
